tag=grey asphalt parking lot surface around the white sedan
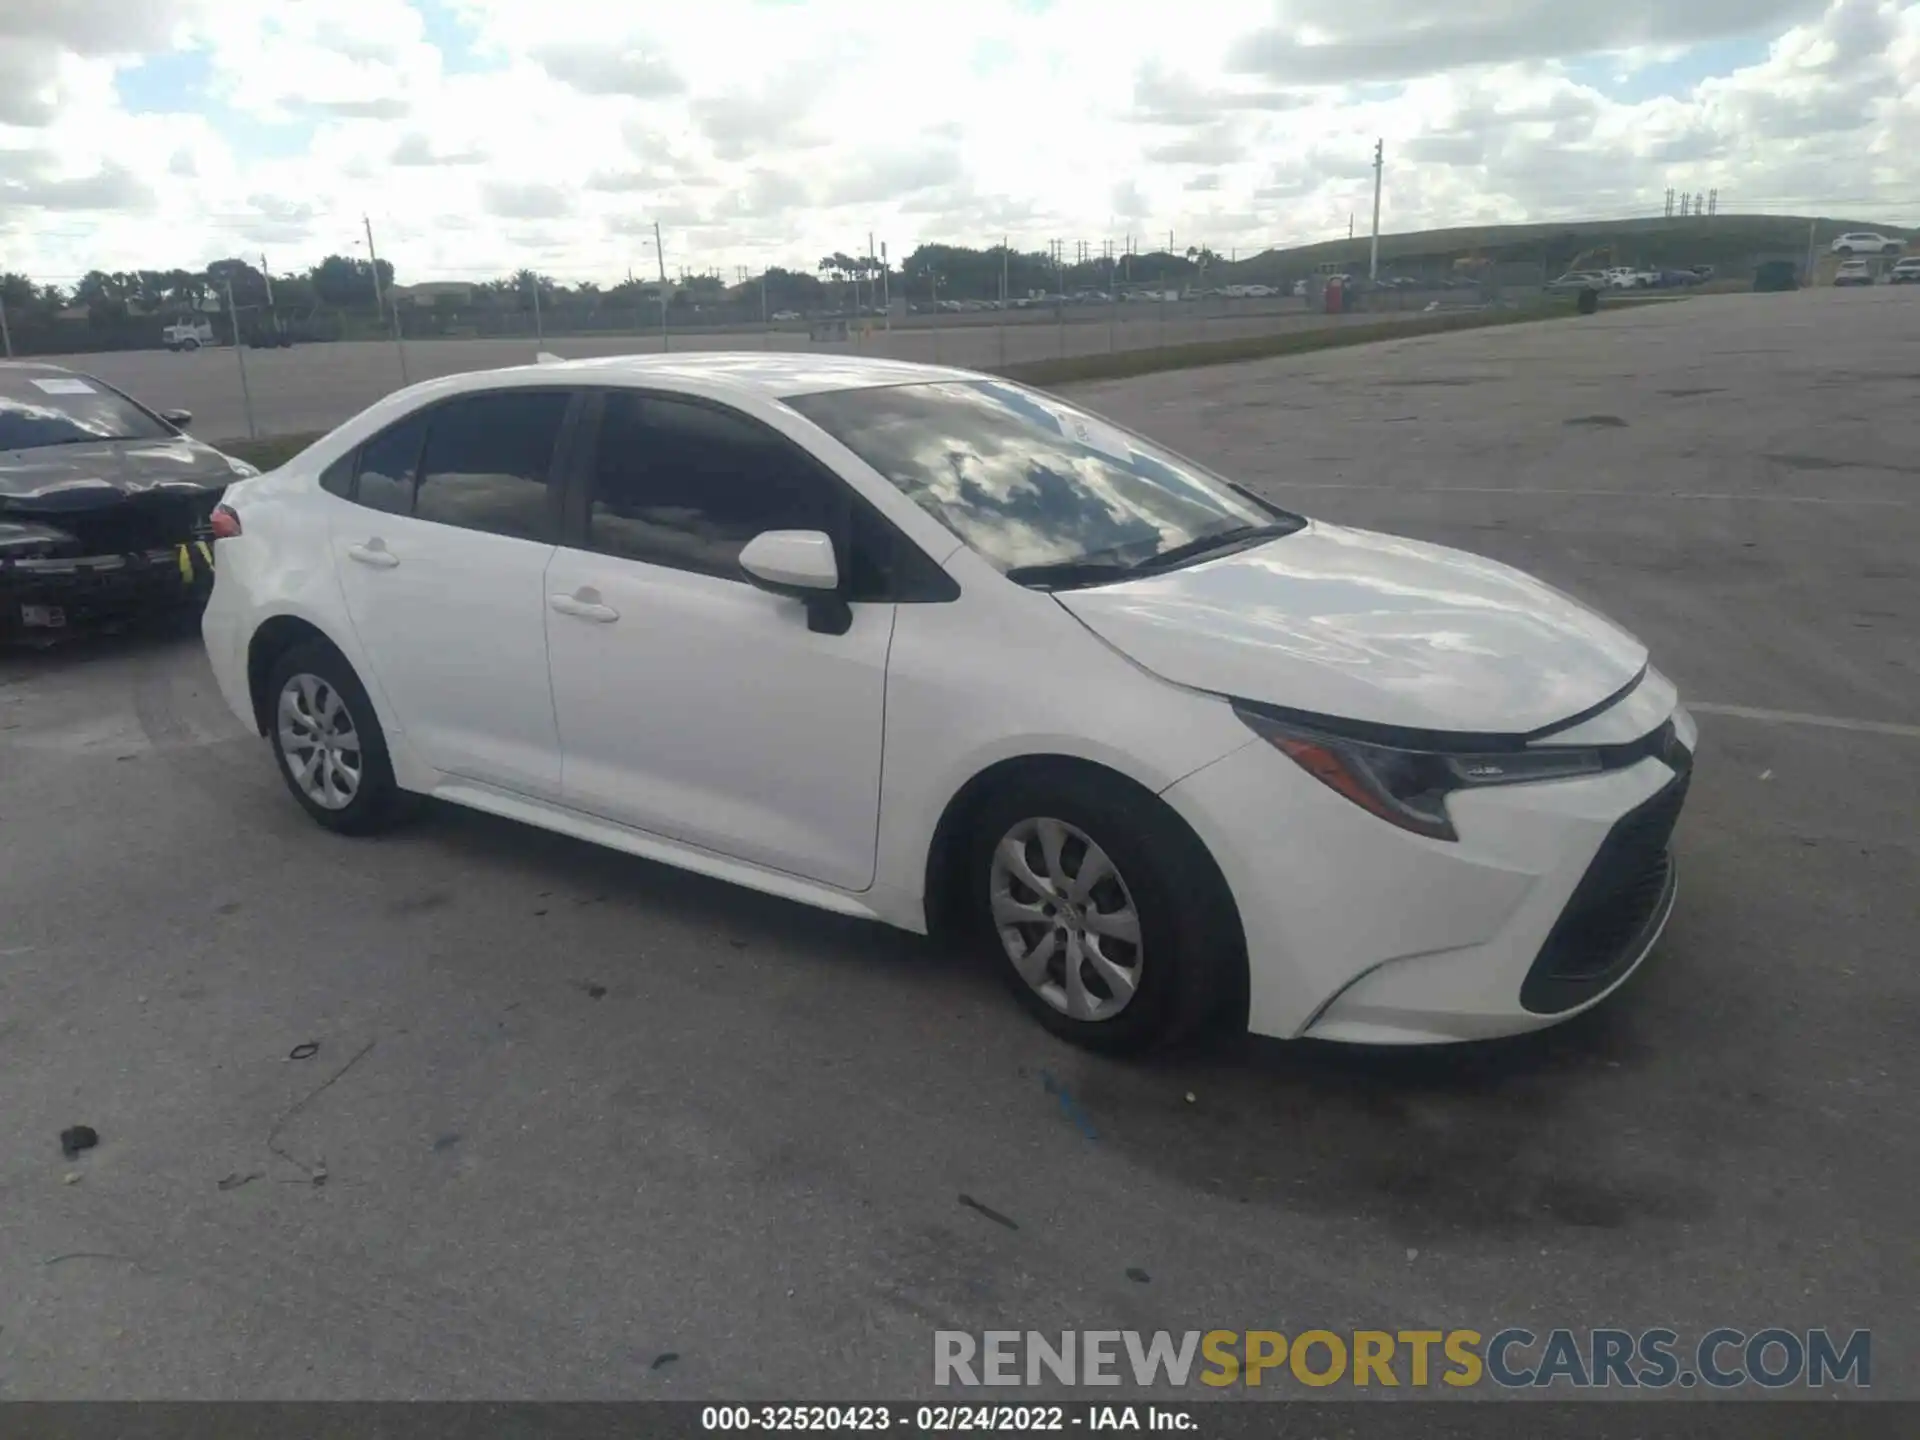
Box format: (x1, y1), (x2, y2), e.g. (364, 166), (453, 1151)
(0, 290), (1920, 1400)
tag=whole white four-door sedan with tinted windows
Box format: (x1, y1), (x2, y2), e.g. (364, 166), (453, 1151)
(204, 353), (1695, 1050)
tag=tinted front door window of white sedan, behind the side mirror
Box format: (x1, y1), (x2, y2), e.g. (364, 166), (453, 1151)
(588, 392), (843, 580)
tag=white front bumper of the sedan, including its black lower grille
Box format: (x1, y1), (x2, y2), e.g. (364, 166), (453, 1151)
(1165, 708), (1697, 1044)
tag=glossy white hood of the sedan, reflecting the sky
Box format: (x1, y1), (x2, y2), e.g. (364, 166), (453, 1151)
(1054, 522), (1647, 733)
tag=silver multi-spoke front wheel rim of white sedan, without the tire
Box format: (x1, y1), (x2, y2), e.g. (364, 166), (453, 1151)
(987, 818), (1144, 1021)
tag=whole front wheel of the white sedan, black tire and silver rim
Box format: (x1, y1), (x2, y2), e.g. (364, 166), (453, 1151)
(966, 774), (1244, 1054)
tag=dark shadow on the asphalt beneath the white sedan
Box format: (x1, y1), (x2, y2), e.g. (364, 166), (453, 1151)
(401, 806), (1715, 1244)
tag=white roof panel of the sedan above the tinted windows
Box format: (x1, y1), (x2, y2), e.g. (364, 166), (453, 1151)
(461, 349), (979, 399)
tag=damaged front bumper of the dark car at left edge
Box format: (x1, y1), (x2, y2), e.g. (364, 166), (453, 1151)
(0, 536), (213, 639)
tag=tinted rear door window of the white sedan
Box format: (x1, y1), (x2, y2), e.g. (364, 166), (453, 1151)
(414, 390), (570, 540)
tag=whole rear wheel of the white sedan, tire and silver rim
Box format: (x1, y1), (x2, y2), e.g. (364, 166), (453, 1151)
(267, 641), (405, 835)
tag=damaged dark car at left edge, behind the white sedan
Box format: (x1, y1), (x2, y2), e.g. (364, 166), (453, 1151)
(0, 363), (257, 643)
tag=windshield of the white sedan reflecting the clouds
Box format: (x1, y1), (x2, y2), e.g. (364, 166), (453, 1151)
(787, 380), (1304, 580)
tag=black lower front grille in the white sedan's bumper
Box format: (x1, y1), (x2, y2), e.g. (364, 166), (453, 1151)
(1521, 768), (1692, 1016)
